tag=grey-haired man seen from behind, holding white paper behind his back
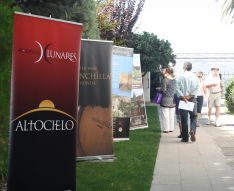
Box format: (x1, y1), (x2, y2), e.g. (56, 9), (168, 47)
(176, 62), (199, 142)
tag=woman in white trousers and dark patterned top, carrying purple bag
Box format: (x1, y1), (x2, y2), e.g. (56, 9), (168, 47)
(160, 68), (176, 133)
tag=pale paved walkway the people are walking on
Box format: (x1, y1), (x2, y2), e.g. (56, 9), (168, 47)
(150, 102), (234, 191)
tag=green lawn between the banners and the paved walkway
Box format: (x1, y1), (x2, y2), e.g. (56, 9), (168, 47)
(76, 106), (160, 191)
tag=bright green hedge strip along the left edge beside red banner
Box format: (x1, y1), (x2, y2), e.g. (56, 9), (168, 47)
(0, 0), (19, 182)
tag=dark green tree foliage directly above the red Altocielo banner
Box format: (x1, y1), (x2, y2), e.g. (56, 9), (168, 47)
(16, 0), (100, 39)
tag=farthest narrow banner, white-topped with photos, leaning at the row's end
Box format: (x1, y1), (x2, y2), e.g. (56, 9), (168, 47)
(130, 54), (148, 130)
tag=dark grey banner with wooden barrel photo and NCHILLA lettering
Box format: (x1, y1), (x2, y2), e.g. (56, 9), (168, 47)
(76, 40), (113, 160)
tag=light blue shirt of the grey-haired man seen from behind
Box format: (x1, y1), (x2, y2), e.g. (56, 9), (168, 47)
(176, 71), (199, 97)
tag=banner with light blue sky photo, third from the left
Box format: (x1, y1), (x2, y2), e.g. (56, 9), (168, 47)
(112, 46), (133, 140)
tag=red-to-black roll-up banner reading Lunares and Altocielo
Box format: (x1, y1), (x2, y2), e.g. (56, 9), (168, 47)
(7, 13), (82, 191)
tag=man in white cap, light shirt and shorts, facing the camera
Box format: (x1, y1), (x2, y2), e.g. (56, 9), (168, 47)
(205, 66), (223, 127)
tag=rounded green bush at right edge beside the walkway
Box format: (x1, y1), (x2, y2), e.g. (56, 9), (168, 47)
(225, 79), (234, 113)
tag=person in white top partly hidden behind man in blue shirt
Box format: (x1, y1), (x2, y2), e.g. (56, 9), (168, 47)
(196, 72), (207, 127)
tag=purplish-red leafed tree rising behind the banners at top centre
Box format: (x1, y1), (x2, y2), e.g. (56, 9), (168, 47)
(97, 0), (145, 45)
